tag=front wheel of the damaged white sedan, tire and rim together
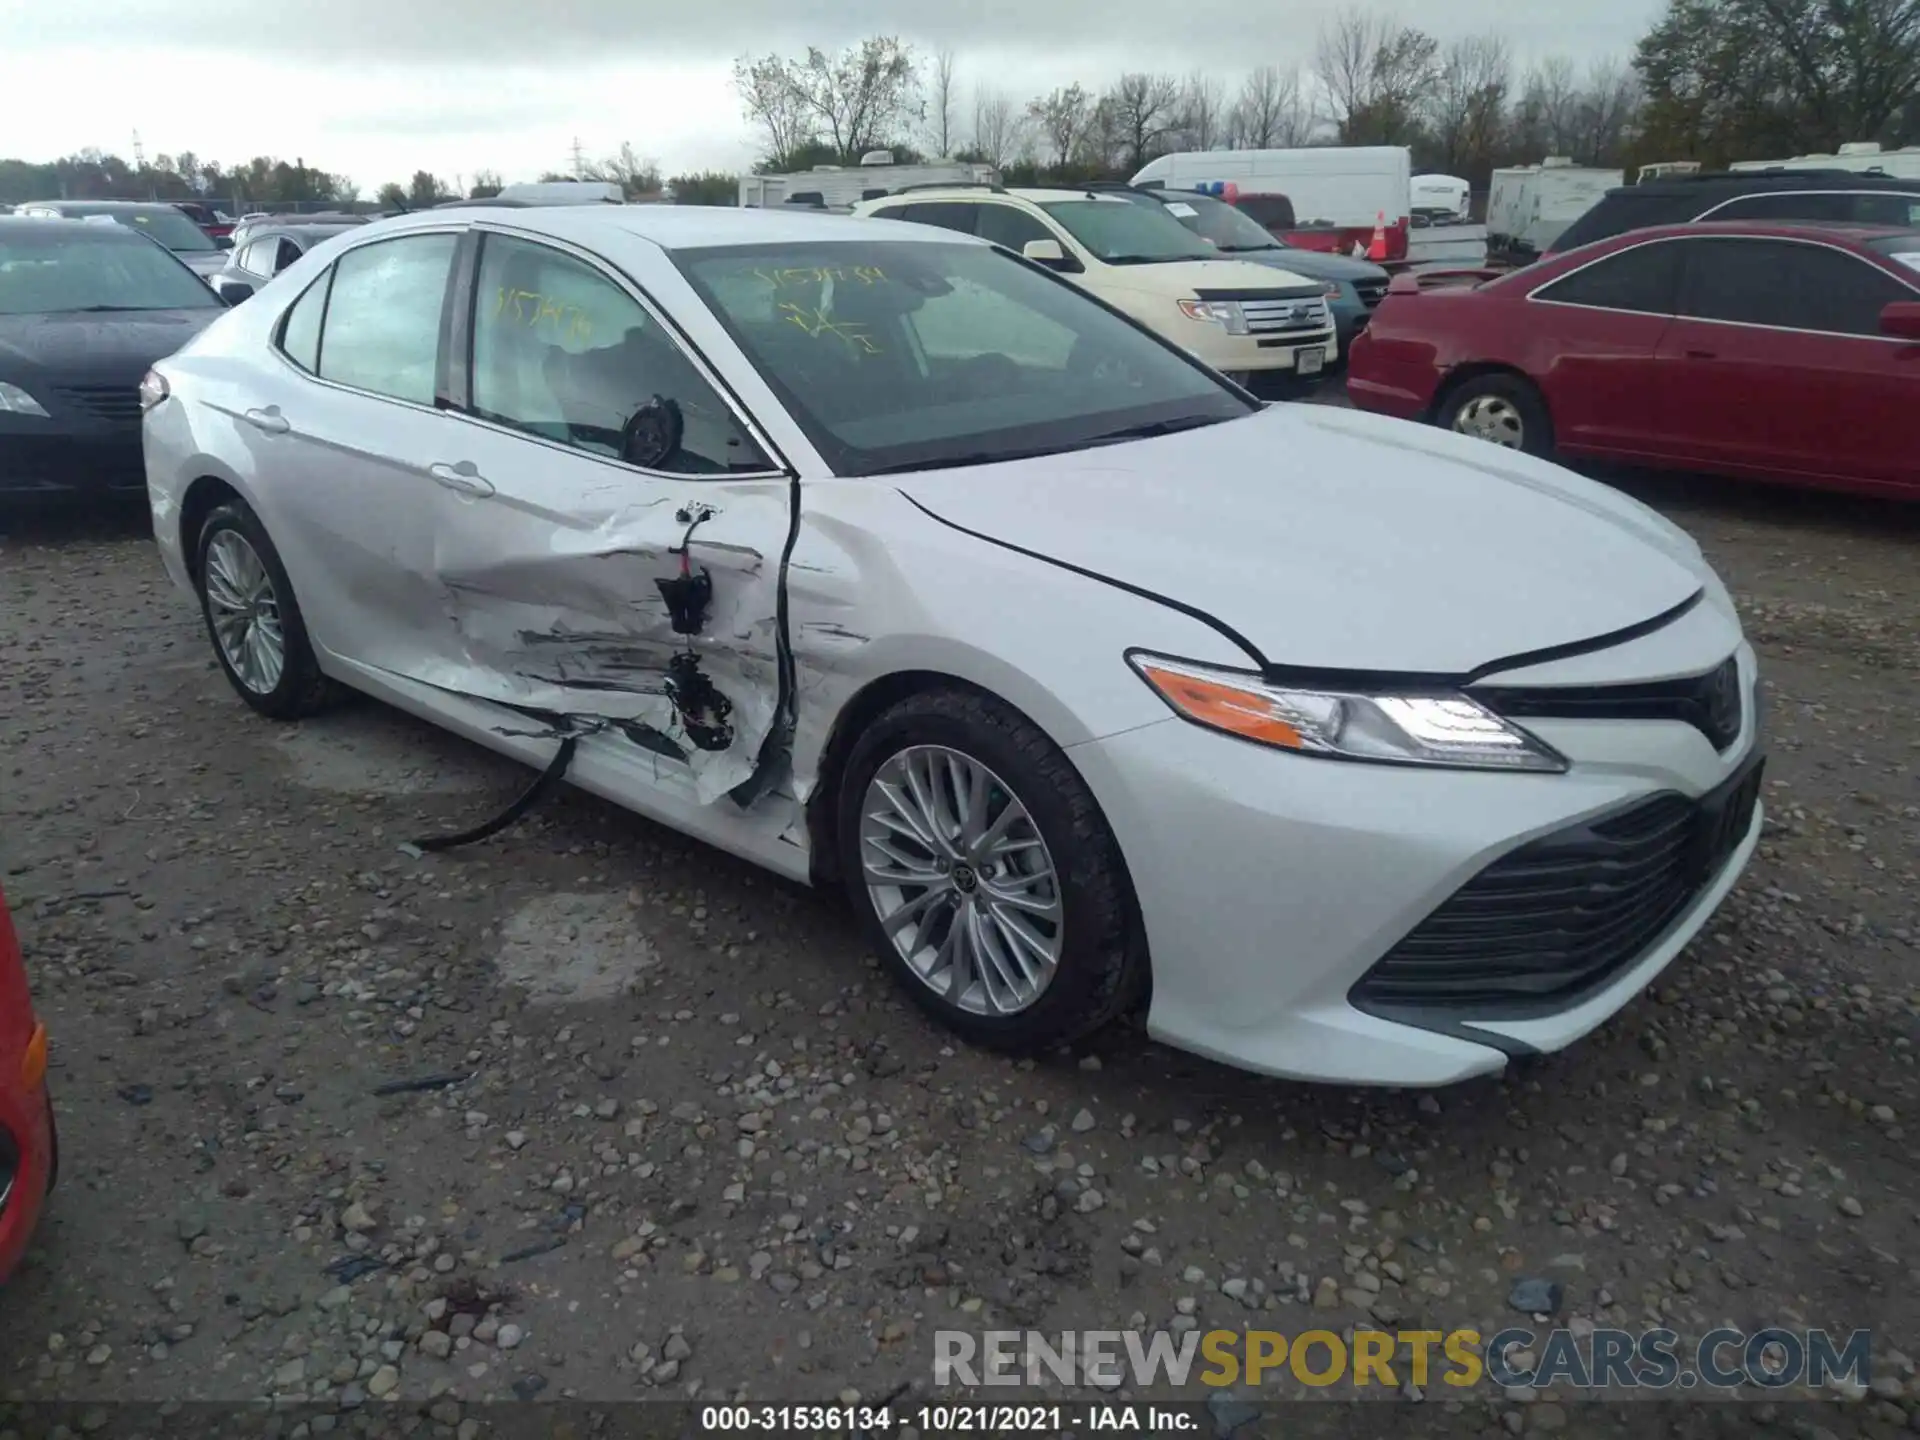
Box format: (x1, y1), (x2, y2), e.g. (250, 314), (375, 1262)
(839, 689), (1146, 1050)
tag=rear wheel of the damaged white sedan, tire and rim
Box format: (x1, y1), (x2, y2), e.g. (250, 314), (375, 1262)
(194, 499), (328, 720)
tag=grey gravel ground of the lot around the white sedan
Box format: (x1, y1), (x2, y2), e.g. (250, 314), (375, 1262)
(0, 426), (1920, 1434)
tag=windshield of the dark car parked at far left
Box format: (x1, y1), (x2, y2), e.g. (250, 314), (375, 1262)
(0, 229), (221, 315)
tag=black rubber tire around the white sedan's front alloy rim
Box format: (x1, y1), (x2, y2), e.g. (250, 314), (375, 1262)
(837, 689), (1148, 1054)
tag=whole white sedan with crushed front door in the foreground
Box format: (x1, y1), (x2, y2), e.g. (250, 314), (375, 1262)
(142, 205), (1761, 1085)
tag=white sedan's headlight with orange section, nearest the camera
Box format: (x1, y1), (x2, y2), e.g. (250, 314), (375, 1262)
(1127, 655), (1567, 774)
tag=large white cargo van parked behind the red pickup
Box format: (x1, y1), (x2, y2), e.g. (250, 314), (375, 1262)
(1133, 146), (1413, 265)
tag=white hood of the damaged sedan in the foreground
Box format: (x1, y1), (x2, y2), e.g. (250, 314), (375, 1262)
(900, 405), (1711, 678)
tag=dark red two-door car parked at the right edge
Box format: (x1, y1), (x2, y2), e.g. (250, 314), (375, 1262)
(1346, 223), (1920, 497)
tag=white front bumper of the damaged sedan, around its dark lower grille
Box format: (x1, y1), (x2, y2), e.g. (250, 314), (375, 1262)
(1071, 645), (1761, 1085)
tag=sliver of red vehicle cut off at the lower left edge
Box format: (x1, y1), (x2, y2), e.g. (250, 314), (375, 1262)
(0, 895), (60, 1281)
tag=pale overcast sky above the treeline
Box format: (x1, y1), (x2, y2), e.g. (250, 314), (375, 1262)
(0, 0), (1659, 194)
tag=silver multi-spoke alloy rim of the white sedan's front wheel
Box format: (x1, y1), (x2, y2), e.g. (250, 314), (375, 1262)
(860, 745), (1066, 1016)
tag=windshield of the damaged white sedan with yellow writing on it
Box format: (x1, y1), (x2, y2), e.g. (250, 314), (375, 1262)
(674, 240), (1254, 476)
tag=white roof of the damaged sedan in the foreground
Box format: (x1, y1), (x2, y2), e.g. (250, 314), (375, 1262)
(353, 204), (987, 250)
